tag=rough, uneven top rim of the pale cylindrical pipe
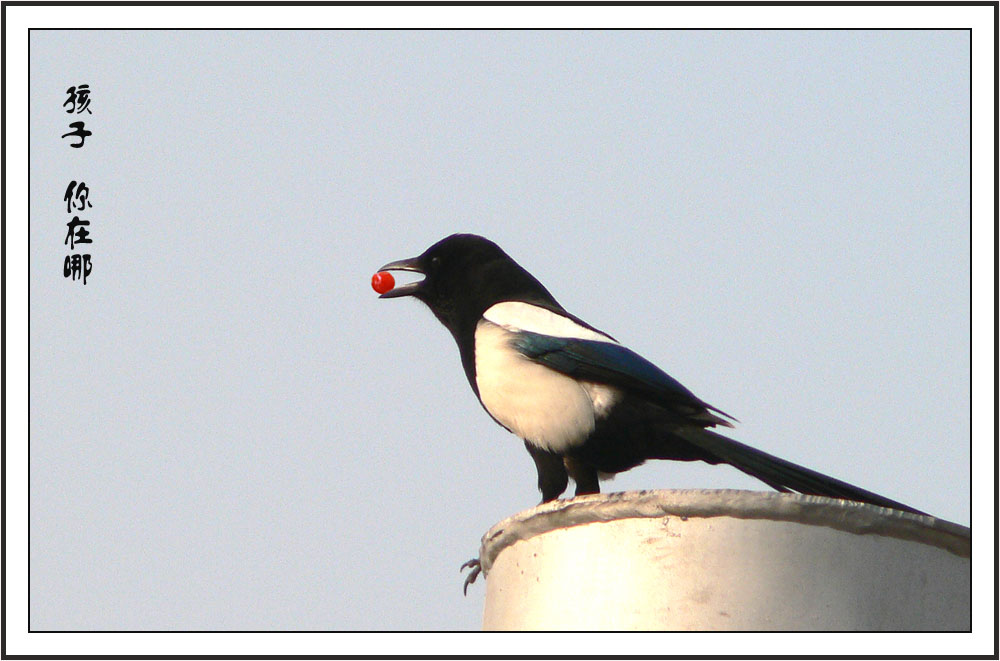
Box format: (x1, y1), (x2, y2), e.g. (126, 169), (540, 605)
(479, 489), (972, 574)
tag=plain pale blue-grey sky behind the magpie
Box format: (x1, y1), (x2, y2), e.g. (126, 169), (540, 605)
(30, 31), (970, 630)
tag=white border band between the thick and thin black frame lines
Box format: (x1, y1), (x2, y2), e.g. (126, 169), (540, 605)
(4, 4), (997, 657)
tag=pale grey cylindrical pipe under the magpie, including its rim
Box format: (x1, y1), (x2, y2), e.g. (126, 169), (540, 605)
(480, 491), (972, 631)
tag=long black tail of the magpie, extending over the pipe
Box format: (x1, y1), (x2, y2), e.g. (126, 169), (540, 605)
(675, 429), (925, 514)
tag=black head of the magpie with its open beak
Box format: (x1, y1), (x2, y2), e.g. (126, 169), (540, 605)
(379, 234), (559, 336)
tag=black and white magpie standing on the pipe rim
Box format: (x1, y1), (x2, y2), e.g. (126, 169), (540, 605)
(379, 234), (923, 520)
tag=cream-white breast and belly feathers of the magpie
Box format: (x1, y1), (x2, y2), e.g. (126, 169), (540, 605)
(475, 319), (616, 453)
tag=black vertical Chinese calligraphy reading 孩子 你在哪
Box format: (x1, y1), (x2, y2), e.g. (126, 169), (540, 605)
(62, 83), (94, 285)
